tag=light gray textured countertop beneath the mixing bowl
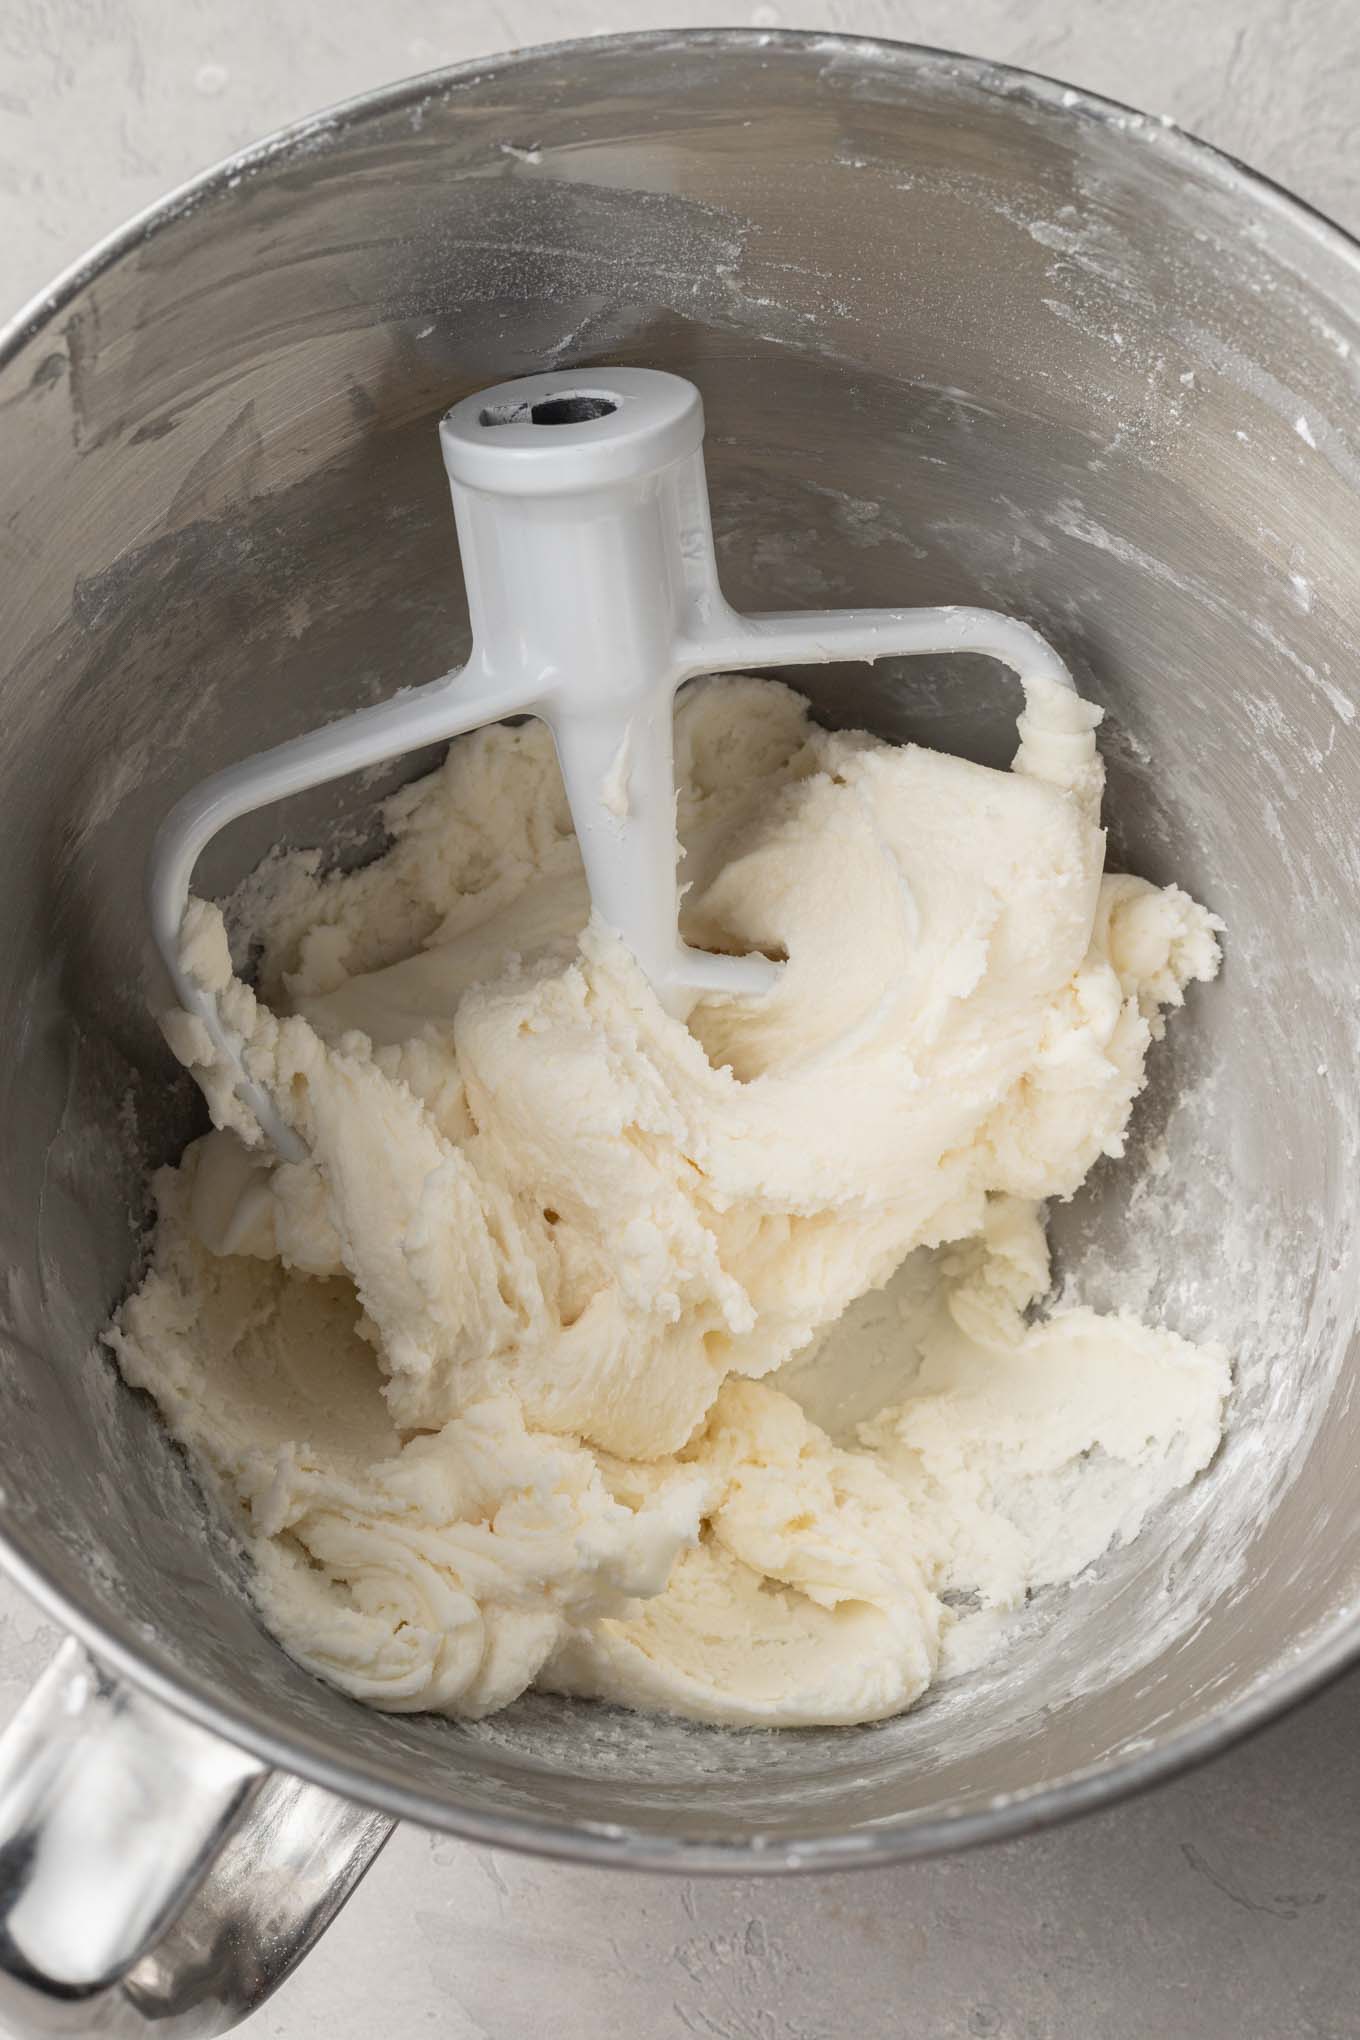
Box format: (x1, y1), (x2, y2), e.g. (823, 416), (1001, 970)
(0, 0), (1360, 2040)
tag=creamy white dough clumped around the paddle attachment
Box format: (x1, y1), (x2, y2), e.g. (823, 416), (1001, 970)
(108, 679), (1230, 1726)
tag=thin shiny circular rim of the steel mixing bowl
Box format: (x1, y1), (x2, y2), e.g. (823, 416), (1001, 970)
(0, 29), (1360, 1877)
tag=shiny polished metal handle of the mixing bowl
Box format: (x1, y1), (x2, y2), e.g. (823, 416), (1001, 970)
(0, 1638), (394, 2040)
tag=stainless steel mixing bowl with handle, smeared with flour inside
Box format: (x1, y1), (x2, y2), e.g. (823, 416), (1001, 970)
(0, 33), (1360, 2032)
